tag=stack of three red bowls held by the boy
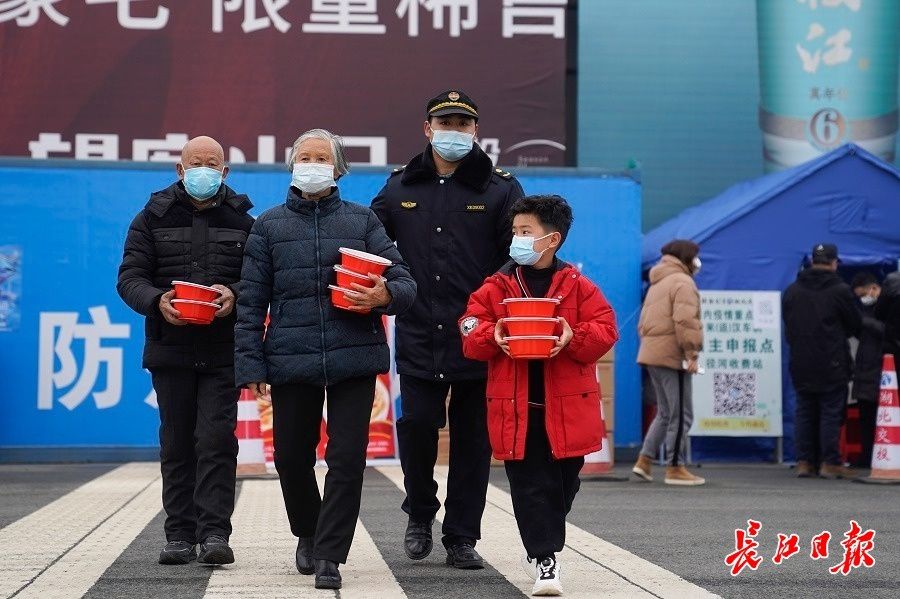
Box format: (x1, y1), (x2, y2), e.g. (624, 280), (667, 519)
(502, 297), (559, 360)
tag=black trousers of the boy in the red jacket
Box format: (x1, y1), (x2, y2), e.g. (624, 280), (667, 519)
(503, 407), (584, 558)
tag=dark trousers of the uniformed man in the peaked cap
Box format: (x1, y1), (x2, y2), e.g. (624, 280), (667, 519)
(397, 376), (491, 547)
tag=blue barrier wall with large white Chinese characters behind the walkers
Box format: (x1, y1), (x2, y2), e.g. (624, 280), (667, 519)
(0, 161), (641, 459)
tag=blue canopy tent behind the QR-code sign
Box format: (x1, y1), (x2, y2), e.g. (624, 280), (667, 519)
(641, 144), (900, 460)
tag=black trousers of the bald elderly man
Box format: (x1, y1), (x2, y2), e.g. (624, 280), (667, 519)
(151, 366), (238, 543)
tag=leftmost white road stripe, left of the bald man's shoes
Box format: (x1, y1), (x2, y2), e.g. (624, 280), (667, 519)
(0, 463), (161, 597)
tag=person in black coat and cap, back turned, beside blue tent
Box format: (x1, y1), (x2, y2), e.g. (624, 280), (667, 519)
(782, 244), (862, 478)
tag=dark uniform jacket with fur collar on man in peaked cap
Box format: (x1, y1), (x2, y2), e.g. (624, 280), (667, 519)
(372, 144), (524, 381)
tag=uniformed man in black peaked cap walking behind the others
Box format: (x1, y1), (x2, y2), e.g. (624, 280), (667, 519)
(372, 90), (524, 569)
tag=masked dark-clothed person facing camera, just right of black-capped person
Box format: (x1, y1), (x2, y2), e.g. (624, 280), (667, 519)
(850, 272), (884, 468)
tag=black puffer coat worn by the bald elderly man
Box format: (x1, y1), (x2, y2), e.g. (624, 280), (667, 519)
(116, 182), (253, 369)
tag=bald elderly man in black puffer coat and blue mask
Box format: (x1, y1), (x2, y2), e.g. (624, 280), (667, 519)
(117, 137), (253, 564)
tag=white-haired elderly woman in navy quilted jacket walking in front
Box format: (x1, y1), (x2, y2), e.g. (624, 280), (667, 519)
(235, 129), (416, 589)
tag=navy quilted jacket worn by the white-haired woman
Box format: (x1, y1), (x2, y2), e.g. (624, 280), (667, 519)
(235, 187), (416, 386)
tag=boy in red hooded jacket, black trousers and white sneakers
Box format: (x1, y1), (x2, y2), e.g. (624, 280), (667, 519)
(459, 196), (618, 595)
